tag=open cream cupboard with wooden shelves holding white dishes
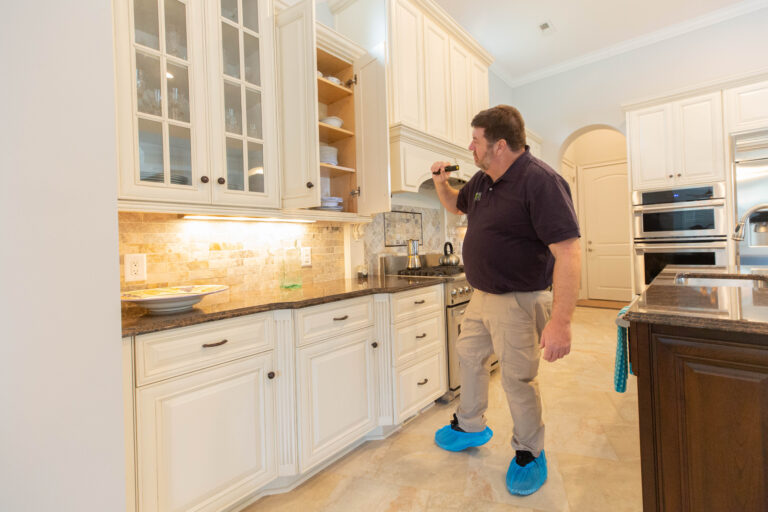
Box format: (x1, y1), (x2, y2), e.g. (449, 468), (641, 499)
(276, 0), (389, 214)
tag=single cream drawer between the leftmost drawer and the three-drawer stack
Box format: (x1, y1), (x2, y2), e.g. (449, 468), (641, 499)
(295, 295), (373, 346)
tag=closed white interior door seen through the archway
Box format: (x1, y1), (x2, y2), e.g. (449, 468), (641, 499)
(579, 162), (632, 301)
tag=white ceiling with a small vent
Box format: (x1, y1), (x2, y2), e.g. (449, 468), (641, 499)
(436, 0), (768, 87)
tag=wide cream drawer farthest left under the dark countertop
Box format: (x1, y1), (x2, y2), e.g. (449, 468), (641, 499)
(136, 313), (274, 386)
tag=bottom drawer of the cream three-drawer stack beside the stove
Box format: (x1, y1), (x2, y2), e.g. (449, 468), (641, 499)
(396, 350), (447, 423)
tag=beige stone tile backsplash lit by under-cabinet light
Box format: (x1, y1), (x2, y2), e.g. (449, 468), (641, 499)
(118, 212), (344, 300)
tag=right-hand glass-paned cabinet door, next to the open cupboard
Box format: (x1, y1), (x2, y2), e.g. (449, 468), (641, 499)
(207, 0), (279, 207)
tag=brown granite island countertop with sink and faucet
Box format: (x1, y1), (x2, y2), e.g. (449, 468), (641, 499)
(624, 266), (768, 334)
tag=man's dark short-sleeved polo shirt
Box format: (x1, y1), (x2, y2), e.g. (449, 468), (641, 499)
(456, 146), (580, 293)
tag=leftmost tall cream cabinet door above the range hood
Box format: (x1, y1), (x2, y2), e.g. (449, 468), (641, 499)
(390, 0), (424, 130)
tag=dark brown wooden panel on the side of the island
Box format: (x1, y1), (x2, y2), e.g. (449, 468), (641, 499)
(654, 335), (768, 512)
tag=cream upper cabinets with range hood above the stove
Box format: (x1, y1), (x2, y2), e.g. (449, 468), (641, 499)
(384, 0), (492, 192)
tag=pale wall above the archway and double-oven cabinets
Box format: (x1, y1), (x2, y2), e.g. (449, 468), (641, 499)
(490, 9), (768, 164)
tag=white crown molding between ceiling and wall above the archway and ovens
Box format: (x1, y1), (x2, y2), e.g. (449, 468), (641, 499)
(492, 0), (768, 89)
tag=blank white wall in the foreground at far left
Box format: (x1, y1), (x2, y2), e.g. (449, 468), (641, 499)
(0, 0), (126, 512)
